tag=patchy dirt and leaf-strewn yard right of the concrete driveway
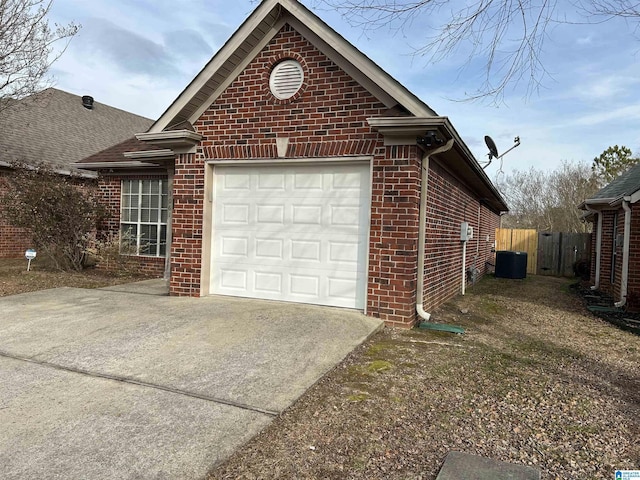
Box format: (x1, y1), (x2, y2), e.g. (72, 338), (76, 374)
(209, 277), (640, 480)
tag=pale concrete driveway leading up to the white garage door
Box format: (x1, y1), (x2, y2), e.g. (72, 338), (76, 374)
(0, 281), (380, 480)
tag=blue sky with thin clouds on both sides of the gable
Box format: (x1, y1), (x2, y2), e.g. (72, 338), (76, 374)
(50, 0), (640, 183)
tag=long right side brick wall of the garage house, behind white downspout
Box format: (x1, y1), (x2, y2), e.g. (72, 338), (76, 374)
(424, 159), (500, 311)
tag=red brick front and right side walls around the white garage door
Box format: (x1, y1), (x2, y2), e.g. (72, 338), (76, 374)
(159, 21), (499, 326)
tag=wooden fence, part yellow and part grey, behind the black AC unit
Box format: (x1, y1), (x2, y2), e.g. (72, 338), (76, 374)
(496, 228), (591, 277)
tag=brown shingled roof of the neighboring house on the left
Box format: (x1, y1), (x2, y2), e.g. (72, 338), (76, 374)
(0, 88), (153, 173)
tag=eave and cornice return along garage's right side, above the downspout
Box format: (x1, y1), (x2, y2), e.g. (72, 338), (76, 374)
(367, 116), (509, 212)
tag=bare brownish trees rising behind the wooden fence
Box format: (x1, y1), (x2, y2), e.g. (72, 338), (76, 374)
(501, 162), (598, 233)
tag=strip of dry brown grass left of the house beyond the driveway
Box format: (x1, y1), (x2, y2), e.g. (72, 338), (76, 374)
(0, 258), (151, 297)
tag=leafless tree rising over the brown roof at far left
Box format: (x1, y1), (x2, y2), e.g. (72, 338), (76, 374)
(0, 0), (80, 112)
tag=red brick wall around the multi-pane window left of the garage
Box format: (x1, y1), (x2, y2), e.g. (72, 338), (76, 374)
(96, 174), (167, 277)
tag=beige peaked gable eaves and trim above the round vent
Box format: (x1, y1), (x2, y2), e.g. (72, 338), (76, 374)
(149, 0), (436, 132)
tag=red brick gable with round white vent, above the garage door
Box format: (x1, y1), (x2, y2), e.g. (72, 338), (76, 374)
(194, 25), (386, 160)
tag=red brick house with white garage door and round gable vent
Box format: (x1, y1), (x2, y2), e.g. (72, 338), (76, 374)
(79, 0), (507, 326)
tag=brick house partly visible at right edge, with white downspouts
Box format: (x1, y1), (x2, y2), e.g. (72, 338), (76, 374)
(579, 164), (640, 310)
